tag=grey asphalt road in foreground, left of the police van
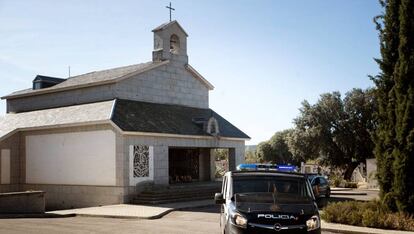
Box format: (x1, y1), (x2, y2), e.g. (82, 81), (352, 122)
(0, 207), (350, 234)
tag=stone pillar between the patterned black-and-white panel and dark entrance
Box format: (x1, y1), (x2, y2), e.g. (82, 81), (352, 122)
(154, 145), (169, 185)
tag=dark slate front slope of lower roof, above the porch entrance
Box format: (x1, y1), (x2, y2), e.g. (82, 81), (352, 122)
(112, 100), (249, 139)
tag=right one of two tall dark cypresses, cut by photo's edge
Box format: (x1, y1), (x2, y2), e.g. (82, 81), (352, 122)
(393, 0), (414, 213)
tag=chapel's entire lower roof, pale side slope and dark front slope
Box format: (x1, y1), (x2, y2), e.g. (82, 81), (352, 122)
(0, 99), (249, 140)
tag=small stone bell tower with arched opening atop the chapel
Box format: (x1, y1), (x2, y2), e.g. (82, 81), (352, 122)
(152, 20), (188, 64)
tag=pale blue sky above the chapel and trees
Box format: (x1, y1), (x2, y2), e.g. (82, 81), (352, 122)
(0, 0), (382, 144)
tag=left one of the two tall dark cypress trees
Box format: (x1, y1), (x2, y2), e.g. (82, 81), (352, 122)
(371, 0), (400, 209)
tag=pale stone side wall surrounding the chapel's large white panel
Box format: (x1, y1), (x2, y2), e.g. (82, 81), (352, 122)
(0, 125), (128, 210)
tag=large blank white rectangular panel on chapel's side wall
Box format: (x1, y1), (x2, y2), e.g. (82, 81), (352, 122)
(26, 130), (116, 185)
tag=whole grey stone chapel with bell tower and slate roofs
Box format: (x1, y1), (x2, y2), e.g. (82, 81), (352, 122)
(0, 21), (249, 208)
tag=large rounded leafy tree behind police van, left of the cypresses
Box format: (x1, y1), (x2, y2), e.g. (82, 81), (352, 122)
(288, 89), (375, 179)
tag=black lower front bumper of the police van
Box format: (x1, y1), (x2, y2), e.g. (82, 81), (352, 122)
(228, 223), (321, 234)
